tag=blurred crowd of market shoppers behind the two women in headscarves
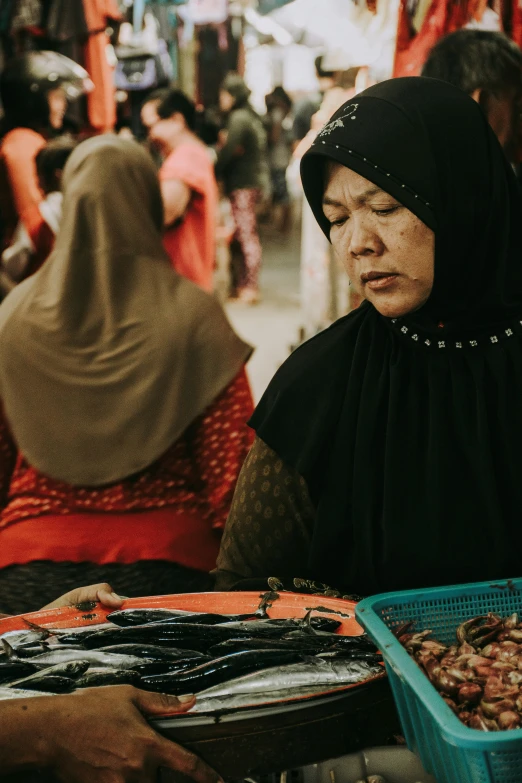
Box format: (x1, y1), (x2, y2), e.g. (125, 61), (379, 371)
(0, 52), (367, 318)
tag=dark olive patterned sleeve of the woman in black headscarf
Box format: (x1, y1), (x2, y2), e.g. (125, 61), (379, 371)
(211, 438), (315, 590)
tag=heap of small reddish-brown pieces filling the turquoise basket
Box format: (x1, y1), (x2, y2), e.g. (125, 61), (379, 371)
(395, 613), (522, 731)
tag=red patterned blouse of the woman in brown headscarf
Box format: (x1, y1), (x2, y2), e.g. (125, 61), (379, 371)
(0, 369), (253, 570)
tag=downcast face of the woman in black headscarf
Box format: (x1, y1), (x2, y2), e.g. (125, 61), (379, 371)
(323, 162), (435, 318)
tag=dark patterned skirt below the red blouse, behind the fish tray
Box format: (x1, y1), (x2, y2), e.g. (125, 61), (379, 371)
(0, 560), (213, 614)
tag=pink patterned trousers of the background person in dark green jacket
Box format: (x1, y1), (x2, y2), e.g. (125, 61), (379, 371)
(230, 188), (262, 290)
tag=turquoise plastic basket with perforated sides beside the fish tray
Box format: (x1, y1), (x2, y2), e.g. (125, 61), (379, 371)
(356, 579), (522, 783)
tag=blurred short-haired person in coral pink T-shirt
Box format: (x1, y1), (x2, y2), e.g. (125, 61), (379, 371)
(141, 90), (218, 291)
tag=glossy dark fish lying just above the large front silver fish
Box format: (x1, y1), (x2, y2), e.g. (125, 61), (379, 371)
(141, 650), (302, 695)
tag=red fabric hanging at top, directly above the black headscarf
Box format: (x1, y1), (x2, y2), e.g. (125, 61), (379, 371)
(393, 0), (470, 76)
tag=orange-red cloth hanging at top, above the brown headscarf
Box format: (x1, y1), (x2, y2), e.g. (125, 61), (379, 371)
(83, 0), (122, 133)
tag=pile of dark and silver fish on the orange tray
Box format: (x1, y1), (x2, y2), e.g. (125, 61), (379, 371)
(0, 601), (383, 712)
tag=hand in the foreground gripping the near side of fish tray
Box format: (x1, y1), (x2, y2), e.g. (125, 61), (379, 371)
(35, 685), (222, 783)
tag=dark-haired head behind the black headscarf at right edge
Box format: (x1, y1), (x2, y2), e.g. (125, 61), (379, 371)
(422, 30), (522, 163)
